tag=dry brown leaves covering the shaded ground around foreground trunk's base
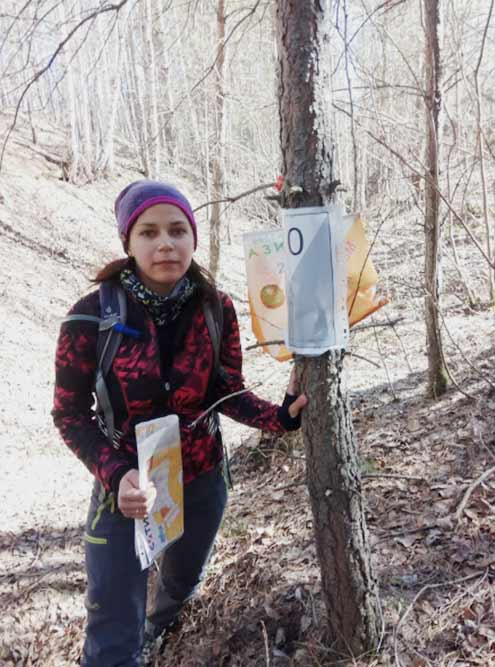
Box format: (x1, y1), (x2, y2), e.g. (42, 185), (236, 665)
(157, 368), (495, 667)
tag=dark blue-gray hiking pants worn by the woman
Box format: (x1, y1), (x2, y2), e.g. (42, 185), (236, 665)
(81, 466), (227, 667)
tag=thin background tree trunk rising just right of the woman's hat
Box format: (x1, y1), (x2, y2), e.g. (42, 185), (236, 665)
(209, 0), (225, 278)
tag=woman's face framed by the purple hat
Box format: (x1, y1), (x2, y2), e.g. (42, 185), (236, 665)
(128, 204), (194, 296)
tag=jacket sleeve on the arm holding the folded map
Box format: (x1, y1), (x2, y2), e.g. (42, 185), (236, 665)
(52, 293), (134, 491)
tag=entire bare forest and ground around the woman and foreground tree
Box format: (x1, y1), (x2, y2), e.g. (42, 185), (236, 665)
(0, 0), (495, 667)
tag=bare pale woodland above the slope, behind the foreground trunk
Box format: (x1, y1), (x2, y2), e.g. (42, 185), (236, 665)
(0, 0), (495, 307)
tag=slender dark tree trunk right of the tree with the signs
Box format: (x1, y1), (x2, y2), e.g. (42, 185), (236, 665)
(423, 0), (447, 398)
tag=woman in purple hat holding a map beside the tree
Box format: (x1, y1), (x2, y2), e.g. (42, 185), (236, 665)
(53, 180), (307, 667)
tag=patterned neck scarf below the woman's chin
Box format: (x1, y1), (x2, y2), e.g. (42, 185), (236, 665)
(120, 269), (196, 327)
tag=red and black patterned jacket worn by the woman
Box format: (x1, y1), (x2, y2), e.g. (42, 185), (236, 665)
(52, 284), (299, 491)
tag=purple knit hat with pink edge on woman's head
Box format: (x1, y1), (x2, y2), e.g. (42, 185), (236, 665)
(115, 180), (198, 249)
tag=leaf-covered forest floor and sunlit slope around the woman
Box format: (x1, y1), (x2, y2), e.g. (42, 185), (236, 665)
(0, 116), (495, 667)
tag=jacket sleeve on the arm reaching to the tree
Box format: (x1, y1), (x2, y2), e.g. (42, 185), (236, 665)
(213, 294), (301, 433)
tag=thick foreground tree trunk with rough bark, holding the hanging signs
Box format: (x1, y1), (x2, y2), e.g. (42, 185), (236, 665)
(277, 0), (380, 660)
